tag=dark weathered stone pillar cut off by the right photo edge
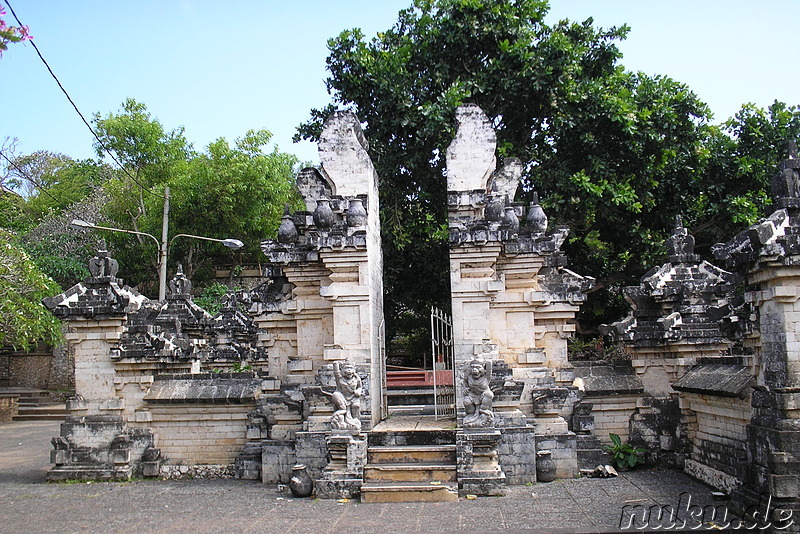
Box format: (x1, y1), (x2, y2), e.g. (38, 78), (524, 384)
(714, 142), (800, 528)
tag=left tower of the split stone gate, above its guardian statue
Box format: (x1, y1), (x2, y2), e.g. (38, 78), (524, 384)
(257, 112), (383, 429)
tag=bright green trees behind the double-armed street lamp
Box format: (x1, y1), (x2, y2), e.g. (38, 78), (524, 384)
(94, 99), (297, 296)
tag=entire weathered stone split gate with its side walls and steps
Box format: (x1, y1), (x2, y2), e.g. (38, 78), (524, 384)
(45, 105), (800, 520)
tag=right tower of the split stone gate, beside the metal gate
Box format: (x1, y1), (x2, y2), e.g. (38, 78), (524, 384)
(447, 105), (594, 482)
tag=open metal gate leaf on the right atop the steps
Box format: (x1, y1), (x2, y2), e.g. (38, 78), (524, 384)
(431, 308), (456, 419)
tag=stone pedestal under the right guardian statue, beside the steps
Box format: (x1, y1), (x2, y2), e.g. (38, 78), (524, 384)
(456, 428), (506, 495)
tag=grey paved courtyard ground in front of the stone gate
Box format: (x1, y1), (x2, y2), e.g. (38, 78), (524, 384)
(0, 422), (752, 534)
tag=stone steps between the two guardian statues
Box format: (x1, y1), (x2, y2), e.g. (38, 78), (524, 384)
(361, 417), (458, 502)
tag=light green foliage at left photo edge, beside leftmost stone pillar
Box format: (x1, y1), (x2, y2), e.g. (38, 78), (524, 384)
(0, 229), (61, 350)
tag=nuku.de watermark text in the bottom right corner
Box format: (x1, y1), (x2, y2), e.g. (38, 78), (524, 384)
(619, 492), (795, 530)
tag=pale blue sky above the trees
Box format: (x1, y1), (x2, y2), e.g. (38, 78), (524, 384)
(0, 0), (800, 168)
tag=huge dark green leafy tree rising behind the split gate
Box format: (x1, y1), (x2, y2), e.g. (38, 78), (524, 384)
(298, 0), (708, 333)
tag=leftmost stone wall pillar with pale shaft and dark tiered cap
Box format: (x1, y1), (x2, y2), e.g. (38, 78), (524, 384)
(44, 250), (152, 480)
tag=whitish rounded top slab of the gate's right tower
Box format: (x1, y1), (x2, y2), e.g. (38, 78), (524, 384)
(447, 104), (497, 191)
